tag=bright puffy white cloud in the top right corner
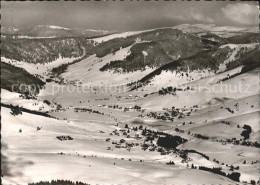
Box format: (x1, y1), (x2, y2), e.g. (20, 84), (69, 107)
(221, 3), (259, 25)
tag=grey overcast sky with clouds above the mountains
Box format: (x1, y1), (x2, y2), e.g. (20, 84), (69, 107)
(1, 0), (259, 31)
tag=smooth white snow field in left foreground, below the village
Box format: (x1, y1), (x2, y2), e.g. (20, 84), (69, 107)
(1, 105), (239, 184)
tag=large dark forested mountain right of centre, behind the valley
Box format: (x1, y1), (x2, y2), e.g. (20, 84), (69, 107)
(96, 26), (259, 72)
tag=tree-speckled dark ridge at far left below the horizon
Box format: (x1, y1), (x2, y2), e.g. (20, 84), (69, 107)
(1, 37), (93, 64)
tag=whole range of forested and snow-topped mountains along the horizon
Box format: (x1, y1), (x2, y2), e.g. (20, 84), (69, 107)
(1, 25), (258, 69)
